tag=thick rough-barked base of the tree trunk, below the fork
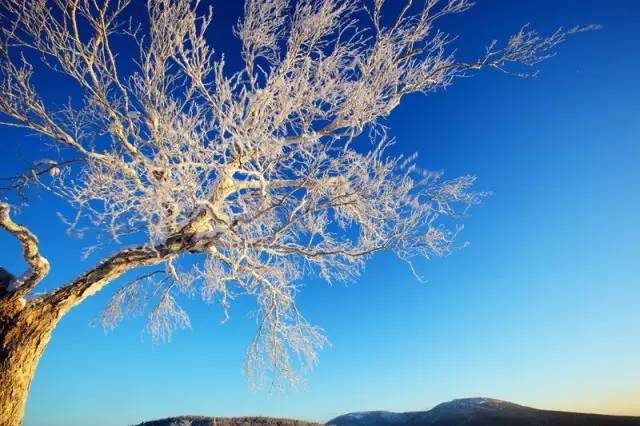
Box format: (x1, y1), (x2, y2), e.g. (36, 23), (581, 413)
(0, 299), (62, 426)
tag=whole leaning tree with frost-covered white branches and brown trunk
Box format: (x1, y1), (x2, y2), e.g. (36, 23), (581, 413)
(0, 0), (591, 425)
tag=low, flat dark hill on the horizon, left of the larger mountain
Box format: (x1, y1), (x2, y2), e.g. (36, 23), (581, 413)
(137, 416), (320, 426)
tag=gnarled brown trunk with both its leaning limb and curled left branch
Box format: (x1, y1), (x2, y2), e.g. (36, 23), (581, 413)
(0, 203), (203, 426)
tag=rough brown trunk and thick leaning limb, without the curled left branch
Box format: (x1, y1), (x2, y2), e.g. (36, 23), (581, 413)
(0, 237), (178, 426)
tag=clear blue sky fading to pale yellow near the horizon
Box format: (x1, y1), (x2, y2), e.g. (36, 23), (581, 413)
(0, 0), (640, 426)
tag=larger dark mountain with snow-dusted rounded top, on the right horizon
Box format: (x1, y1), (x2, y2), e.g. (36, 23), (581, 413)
(327, 398), (640, 426)
